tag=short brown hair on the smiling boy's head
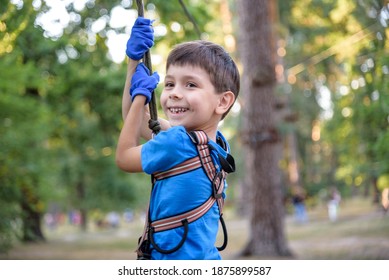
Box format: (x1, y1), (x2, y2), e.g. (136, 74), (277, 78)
(166, 40), (240, 119)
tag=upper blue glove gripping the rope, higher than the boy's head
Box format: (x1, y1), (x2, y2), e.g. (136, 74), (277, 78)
(126, 17), (154, 60)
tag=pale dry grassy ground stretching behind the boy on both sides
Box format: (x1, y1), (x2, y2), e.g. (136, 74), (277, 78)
(0, 199), (389, 260)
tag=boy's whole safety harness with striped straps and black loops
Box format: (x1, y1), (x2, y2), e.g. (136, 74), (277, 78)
(136, 130), (235, 260)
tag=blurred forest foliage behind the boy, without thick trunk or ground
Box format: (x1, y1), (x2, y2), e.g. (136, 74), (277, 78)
(0, 0), (389, 258)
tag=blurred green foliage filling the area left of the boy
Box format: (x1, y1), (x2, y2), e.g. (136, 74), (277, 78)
(0, 1), (150, 250)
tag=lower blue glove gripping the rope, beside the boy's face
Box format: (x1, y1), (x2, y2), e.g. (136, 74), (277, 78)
(130, 63), (159, 104)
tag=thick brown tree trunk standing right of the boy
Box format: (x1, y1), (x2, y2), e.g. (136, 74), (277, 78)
(237, 0), (291, 257)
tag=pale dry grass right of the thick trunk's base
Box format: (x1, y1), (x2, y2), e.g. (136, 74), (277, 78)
(287, 200), (389, 260)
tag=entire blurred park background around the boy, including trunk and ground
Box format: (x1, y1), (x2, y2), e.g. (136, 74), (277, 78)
(0, 0), (389, 259)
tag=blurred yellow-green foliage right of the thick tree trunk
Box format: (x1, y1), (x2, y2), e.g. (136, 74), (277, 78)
(278, 0), (389, 197)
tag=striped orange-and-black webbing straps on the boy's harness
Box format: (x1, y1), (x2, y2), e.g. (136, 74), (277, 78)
(136, 131), (227, 256)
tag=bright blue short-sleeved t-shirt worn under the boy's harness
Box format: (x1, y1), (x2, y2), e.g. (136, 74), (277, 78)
(141, 126), (228, 260)
